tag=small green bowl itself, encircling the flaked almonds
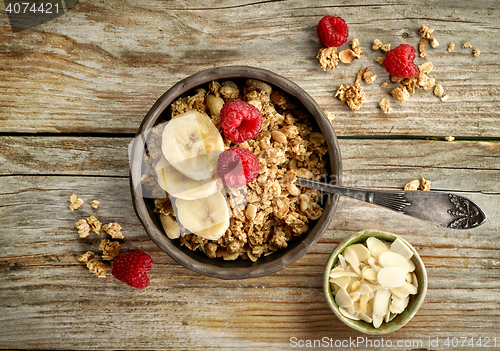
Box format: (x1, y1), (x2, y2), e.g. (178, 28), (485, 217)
(323, 230), (427, 335)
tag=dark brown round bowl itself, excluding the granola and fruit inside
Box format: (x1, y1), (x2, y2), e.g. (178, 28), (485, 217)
(129, 66), (342, 279)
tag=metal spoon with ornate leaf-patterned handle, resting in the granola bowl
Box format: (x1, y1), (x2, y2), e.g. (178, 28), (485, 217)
(296, 177), (486, 229)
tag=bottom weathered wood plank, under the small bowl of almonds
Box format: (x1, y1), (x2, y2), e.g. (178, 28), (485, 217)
(0, 176), (500, 350)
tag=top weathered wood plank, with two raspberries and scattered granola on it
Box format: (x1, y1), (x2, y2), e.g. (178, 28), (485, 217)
(0, 0), (500, 137)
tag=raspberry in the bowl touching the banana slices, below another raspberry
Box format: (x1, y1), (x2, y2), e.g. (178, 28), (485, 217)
(217, 147), (259, 188)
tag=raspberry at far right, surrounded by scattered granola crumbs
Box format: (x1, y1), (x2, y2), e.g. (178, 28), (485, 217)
(384, 44), (418, 78)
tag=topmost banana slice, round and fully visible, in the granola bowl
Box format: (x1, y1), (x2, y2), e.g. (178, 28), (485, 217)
(162, 110), (224, 180)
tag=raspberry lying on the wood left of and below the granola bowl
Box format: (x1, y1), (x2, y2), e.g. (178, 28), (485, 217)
(111, 251), (153, 289)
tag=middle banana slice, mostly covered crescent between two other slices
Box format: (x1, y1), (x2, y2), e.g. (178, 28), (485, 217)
(156, 157), (222, 200)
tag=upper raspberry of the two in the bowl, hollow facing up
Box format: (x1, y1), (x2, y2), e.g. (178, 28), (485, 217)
(220, 100), (262, 144)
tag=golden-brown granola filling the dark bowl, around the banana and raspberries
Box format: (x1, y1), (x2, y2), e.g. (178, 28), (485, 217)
(143, 79), (328, 261)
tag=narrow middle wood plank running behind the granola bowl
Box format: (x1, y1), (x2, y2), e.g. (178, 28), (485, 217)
(0, 137), (500, 193)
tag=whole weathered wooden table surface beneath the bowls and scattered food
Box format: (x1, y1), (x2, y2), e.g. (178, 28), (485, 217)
(0, 0), (500, 350)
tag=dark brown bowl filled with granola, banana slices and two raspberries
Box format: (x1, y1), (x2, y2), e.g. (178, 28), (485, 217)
(129, 66), (341, 279)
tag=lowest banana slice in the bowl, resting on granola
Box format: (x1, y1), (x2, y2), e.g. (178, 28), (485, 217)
(174, 191), (229, 240)
